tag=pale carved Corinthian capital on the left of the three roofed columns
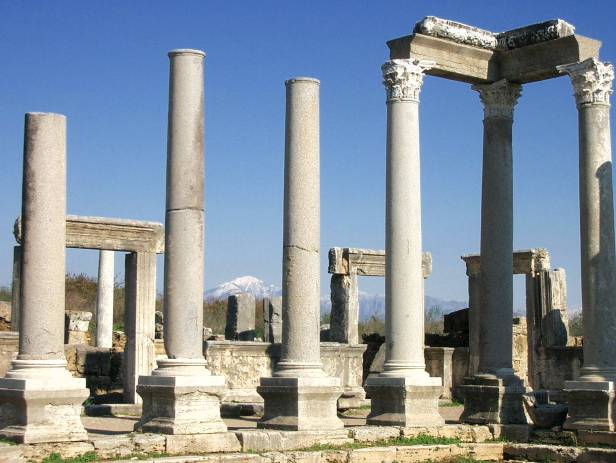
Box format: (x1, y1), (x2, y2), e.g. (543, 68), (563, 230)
(381, 59), (435, 101)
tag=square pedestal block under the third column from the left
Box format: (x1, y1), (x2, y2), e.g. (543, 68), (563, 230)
(257, 376), (344, 431)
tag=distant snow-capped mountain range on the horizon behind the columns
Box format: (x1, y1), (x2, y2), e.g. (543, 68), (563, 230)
(205, 275), (468, 320)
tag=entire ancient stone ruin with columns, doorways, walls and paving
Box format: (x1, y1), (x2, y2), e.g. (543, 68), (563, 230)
(0, 12), (616, 462)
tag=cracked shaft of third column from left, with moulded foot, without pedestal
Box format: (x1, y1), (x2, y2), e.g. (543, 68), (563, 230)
(275, 78), (323, 376)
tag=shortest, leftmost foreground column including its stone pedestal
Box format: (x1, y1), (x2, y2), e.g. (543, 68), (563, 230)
(0, 113), (89, 443)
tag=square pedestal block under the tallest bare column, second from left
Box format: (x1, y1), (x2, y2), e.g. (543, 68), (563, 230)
(135, 369), (227, 434)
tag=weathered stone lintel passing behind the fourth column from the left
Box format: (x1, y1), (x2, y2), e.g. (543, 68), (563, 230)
(328, 248), (432, 278)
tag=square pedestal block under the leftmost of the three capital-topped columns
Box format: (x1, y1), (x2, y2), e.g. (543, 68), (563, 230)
(364, 375), (445, 428)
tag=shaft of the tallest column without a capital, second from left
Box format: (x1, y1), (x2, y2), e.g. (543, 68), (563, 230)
(164, 50), (204, 359)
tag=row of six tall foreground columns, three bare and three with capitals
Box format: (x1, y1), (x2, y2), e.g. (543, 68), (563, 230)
(0, 50), (616, 442)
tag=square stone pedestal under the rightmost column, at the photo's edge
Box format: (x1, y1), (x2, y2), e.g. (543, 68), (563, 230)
(563, 381), (616, 431)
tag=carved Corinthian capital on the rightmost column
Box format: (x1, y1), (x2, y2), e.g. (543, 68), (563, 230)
(556, 58), (614, 106)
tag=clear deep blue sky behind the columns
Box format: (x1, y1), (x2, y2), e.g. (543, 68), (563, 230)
(0, 0), (616, 309)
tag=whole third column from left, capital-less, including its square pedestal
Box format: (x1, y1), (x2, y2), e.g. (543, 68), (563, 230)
(257, 77), (343, 430)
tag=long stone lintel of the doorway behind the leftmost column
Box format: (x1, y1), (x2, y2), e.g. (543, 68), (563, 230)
(13, 215), (165, 254)
